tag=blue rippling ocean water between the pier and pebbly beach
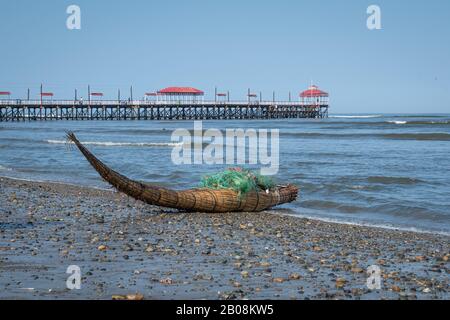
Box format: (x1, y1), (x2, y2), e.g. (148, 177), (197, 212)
(0, 114), (450, 234)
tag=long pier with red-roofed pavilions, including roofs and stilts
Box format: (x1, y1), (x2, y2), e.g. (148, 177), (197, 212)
(0, 86), (329, 122)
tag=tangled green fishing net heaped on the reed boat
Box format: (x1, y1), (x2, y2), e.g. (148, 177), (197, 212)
(200, 168), (275, 195)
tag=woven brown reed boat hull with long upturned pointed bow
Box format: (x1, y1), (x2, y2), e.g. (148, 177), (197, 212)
(67, 132), (298, 213)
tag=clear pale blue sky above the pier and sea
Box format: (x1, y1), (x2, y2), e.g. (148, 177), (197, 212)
(0, 0), (450, 113)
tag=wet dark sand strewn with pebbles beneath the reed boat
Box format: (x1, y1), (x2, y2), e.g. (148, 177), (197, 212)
(0, 178), (450, 299)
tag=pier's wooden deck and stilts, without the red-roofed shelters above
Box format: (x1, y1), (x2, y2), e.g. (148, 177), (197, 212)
(0, 100), (328, 122)
